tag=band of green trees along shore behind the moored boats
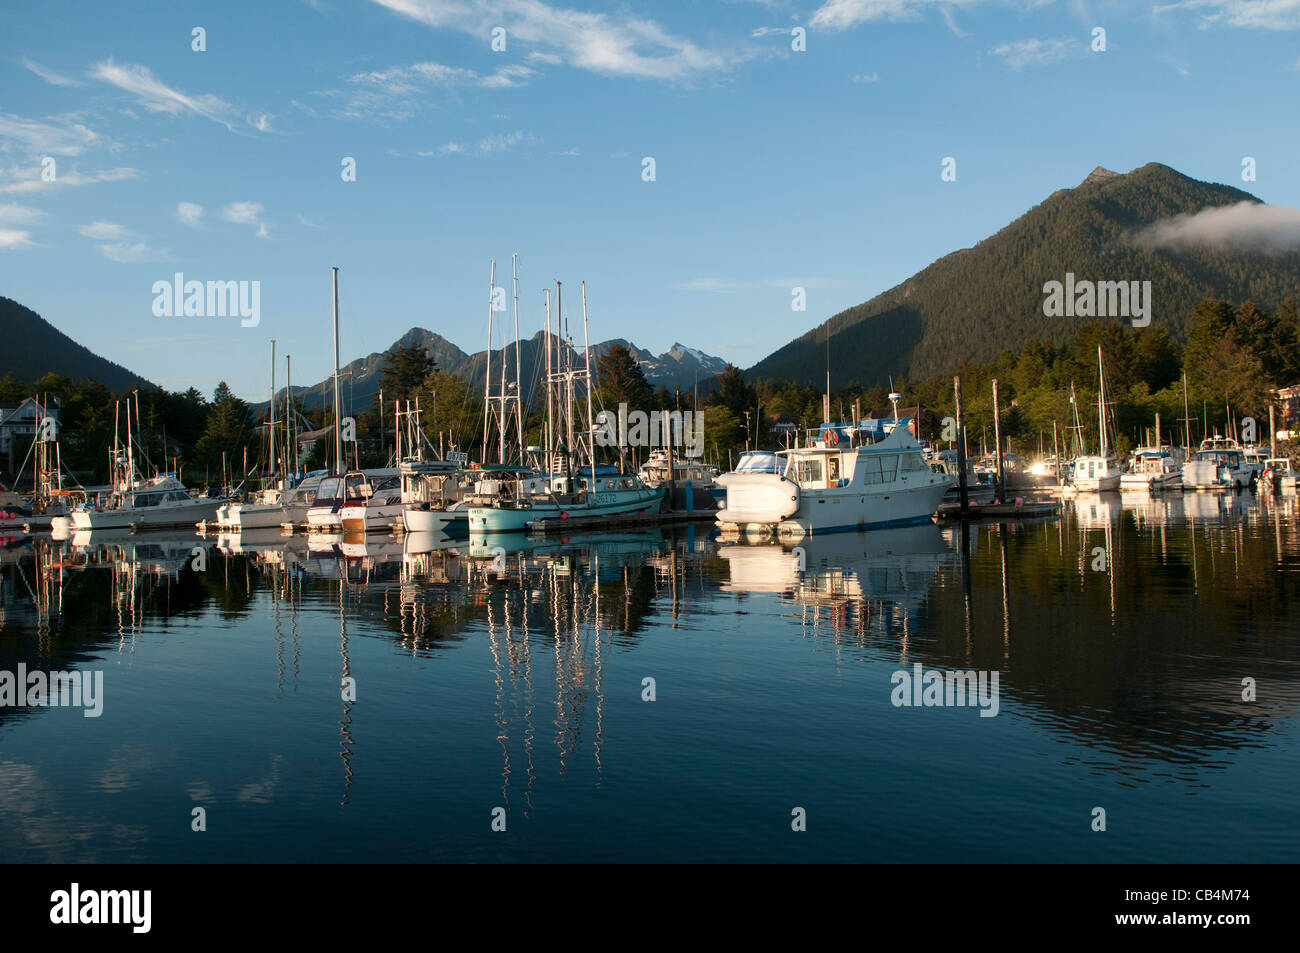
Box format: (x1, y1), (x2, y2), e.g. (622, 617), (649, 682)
(0, 293), (1300, 485)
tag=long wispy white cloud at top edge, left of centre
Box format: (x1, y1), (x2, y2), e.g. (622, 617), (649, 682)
(372, 0), (755, 81)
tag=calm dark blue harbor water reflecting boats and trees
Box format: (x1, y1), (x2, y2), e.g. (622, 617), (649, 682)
(0, 494), (1300, 862)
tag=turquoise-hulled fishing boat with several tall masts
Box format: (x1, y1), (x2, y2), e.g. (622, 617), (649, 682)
(467, 276), (667, 534)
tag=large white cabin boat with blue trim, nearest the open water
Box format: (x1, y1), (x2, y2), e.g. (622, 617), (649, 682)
(716, 417), (950, 537)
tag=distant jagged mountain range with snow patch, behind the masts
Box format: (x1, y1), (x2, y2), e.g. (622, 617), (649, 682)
(284, 328), (727, 408)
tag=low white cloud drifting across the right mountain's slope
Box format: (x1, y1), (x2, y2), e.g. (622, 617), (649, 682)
(1132, 202), (1300, 254)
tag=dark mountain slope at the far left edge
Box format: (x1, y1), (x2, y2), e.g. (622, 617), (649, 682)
(0, 296), (153, 393)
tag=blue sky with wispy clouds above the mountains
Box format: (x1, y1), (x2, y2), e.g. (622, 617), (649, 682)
(0, 0), (1300, 399)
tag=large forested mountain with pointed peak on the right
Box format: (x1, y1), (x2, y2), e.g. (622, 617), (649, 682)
(746, 163), (1300, 386)
